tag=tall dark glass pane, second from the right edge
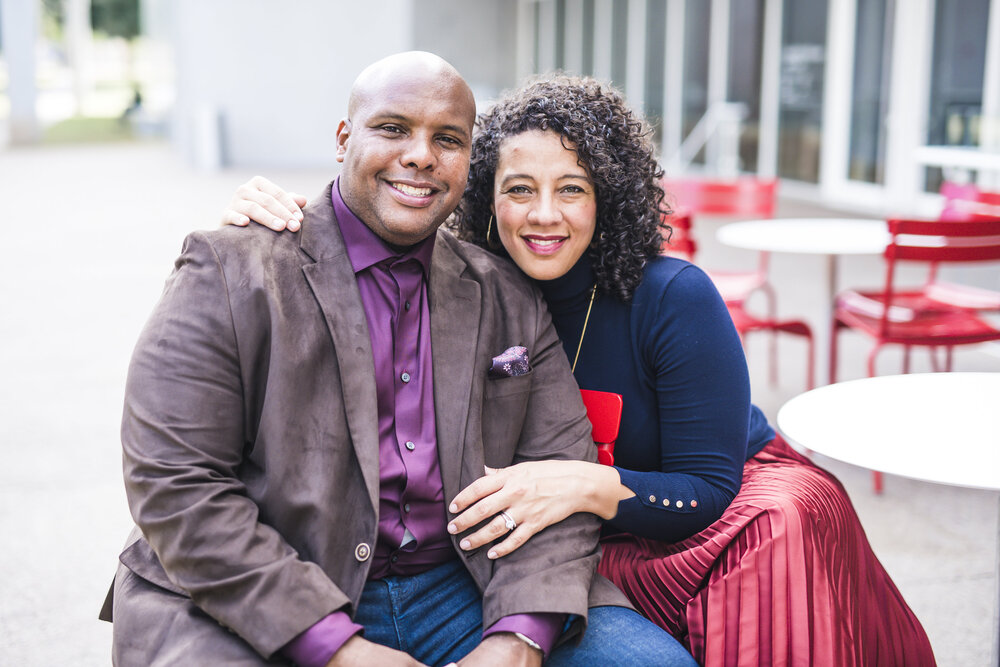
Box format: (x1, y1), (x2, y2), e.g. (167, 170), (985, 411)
(847, 0), (895, 183)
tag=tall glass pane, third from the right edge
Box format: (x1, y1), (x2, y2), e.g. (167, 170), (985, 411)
(778, 0), (827, 183)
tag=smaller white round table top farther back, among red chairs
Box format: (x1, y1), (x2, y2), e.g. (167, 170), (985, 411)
(715, 218), (889, 255)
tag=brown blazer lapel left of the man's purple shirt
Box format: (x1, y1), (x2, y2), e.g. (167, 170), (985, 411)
(300, 184), (379, 515)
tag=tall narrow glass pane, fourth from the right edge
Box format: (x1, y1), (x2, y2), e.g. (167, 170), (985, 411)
(726, 0), (764, 172)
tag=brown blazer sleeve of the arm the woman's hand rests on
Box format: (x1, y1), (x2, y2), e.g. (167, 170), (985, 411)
(474, 294), (600, 639)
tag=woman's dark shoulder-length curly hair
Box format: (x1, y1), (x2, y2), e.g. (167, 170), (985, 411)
(452, 75), (669, 303)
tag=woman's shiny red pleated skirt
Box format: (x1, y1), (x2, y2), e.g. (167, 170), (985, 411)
(599, 436), (935, 667)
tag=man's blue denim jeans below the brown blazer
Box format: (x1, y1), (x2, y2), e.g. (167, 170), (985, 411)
(354, 561), (697, 667)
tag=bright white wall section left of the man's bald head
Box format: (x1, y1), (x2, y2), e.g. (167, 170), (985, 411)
(171, 0), (414, 168)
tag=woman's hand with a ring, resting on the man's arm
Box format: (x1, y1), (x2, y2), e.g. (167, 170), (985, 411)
(448, 461), (634, 558)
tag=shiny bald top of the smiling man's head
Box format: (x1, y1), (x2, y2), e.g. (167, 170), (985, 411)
(347, 51), (476, 127)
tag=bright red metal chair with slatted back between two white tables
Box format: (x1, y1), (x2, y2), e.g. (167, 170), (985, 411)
(830, 217), (1000, 492)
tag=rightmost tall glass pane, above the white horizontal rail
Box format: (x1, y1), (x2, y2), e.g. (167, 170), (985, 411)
(927, 0), (988, 192)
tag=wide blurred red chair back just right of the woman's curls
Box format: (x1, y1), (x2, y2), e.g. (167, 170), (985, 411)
(663, 177), (778, 218)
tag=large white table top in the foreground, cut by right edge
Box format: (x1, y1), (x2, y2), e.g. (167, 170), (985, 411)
(778, 373), (1000, 490)
